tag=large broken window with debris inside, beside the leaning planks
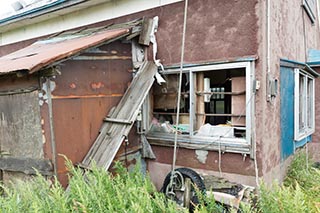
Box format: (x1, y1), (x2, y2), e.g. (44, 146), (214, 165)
(149, 62), (254, 155)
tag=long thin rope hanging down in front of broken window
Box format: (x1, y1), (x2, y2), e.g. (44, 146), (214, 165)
(170, 0), (188, 176)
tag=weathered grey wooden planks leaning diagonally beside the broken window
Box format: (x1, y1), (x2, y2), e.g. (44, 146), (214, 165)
(82, 62), (157, 170)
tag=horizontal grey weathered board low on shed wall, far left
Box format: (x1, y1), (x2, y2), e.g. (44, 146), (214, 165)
(0, 156), (53, 175)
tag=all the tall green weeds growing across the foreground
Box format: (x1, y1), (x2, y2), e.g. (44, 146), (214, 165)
(0, 154), (320, 213)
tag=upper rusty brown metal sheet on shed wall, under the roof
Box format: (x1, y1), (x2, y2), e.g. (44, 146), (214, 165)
(52, 47), (132, 98)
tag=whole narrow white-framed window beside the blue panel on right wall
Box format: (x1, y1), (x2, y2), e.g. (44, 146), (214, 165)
(295, 69), (314, 140)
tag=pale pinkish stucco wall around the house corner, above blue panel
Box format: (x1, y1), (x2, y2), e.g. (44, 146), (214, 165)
(256, 0), (319, 180)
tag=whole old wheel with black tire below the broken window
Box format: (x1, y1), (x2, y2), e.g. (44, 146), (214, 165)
(161, 168), (206, 212)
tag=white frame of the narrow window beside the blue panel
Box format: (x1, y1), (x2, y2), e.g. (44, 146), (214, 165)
(294, 68), (315, 141)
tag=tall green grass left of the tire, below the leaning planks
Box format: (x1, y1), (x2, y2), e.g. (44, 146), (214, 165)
(0, 161), (186, 213)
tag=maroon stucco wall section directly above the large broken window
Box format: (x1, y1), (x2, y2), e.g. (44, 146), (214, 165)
(157, 0), (258, 64)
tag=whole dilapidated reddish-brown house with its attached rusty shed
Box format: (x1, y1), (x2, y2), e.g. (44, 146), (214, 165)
(0, 0), (320, 188)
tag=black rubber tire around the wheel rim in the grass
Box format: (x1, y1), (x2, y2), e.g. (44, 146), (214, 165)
(161, 168), (206, 212)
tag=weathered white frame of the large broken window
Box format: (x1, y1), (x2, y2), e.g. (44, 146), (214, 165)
(150, 61), (255, 157)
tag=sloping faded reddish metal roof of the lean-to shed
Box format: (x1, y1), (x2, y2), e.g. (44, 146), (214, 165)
(0, 27), (130, 75)
